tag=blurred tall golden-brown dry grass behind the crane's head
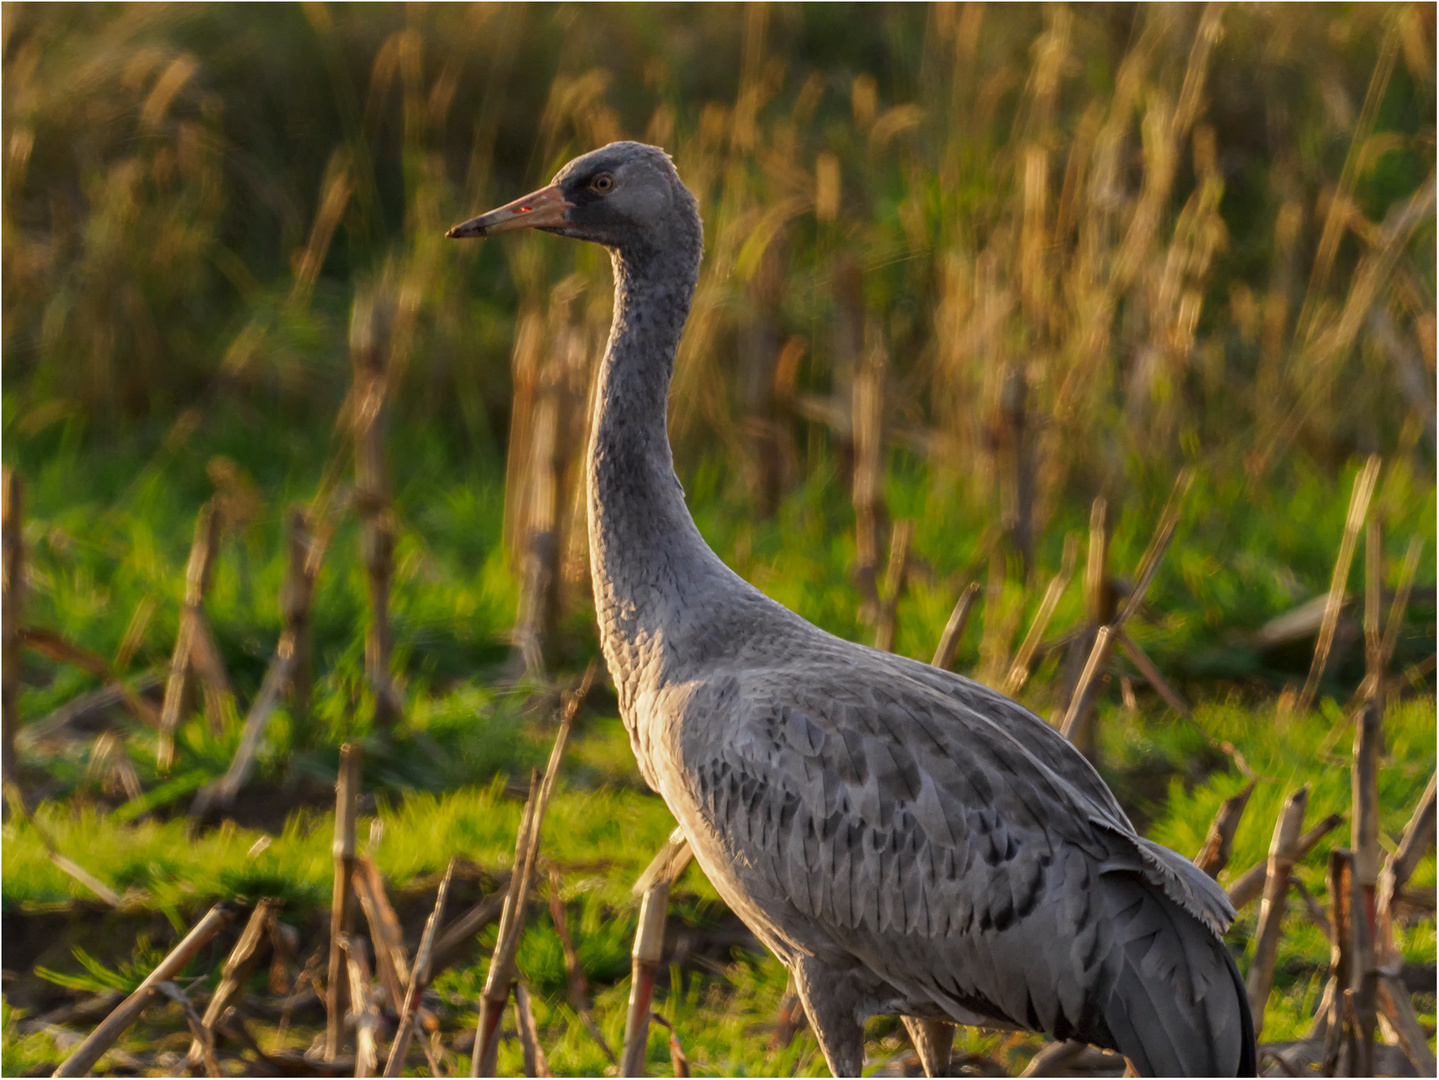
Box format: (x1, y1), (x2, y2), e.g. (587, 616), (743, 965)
(3, 4), (1435, 480)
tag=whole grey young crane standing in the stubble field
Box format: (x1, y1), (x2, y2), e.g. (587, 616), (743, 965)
(452, 142), (1255, 1076)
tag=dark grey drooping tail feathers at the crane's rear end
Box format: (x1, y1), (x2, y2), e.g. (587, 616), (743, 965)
(1102, 874), (1256, 1076)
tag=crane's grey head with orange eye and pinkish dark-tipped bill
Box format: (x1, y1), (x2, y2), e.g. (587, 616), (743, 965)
(446, 142), (698, 249)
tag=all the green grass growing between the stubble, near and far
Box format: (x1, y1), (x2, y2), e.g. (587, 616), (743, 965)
(0, 421), (1435, 1074)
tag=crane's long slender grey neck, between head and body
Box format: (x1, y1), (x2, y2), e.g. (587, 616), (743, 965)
(589, 225), (728, 715)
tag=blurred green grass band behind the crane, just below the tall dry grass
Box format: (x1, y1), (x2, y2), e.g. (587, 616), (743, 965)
(6, 398), (1436, 814)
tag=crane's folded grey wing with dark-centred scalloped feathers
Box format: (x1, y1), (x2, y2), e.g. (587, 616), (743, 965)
(667, 650), (1235, 1066)
